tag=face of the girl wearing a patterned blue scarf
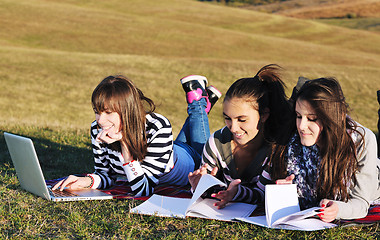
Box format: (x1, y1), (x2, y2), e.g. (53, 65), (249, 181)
(296, 100), (323, 146)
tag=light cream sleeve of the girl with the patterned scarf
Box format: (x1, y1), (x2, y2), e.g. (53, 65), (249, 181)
(334, 127), (380, 219)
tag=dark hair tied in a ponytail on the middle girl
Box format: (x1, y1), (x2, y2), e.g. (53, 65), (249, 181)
(224, 64), (291, 142)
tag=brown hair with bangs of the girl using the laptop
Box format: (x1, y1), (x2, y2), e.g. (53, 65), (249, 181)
(91, 75), (155, 161)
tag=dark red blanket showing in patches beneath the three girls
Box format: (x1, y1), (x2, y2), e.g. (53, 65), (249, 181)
(46, 177), (380, 226)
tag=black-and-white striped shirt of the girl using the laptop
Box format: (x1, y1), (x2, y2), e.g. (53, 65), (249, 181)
(90, 113), (174, 196)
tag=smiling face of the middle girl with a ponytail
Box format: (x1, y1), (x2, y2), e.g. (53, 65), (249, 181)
(223, 98), (260, 145)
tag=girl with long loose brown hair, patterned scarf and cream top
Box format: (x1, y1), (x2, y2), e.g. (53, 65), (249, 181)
(268, 78), (380, 222)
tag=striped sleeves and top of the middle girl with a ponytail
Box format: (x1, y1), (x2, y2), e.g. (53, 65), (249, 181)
(202, 127), (270, 204)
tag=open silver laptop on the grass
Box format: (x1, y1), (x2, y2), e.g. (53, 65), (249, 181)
(4, 132), (113, 202)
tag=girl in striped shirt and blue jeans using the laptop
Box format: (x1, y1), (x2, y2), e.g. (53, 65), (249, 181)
(53, 75), (221, 196)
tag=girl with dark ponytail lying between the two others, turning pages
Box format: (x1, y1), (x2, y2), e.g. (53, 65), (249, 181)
(189, 64), (291, 208)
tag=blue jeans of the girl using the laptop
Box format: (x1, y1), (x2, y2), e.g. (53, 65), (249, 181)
(160, 98), (210, 185)
